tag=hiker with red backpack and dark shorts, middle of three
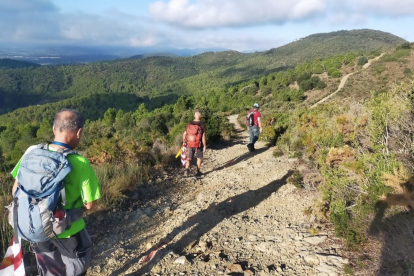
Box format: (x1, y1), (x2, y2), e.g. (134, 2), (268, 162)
(183, 109), (206, 177)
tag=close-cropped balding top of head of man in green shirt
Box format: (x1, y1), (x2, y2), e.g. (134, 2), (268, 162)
(53, 109), (85, 132)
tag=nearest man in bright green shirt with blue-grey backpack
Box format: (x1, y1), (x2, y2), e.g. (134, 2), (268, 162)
(11, 109), (101, 276)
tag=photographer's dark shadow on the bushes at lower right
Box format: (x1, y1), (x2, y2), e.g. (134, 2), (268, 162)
(369, 182), (414, 276)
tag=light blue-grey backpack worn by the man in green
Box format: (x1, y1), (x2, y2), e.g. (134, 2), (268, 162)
(9, 144), (82, 242)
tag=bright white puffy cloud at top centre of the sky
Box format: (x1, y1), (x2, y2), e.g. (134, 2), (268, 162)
(149, 0), (326, 28)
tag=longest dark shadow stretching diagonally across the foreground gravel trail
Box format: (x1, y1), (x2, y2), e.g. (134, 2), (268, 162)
(111, 171), (293, 276)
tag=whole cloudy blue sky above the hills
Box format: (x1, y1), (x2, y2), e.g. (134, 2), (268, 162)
(0, 0), (414, 51)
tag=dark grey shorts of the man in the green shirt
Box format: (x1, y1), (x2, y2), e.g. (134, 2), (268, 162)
(31, 228), (92, 276)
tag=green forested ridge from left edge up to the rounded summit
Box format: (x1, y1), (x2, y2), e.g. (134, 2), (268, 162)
(0, 30), (404, 114)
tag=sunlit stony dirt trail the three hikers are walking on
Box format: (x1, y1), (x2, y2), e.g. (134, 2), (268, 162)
(88, 116), (348, 276)
